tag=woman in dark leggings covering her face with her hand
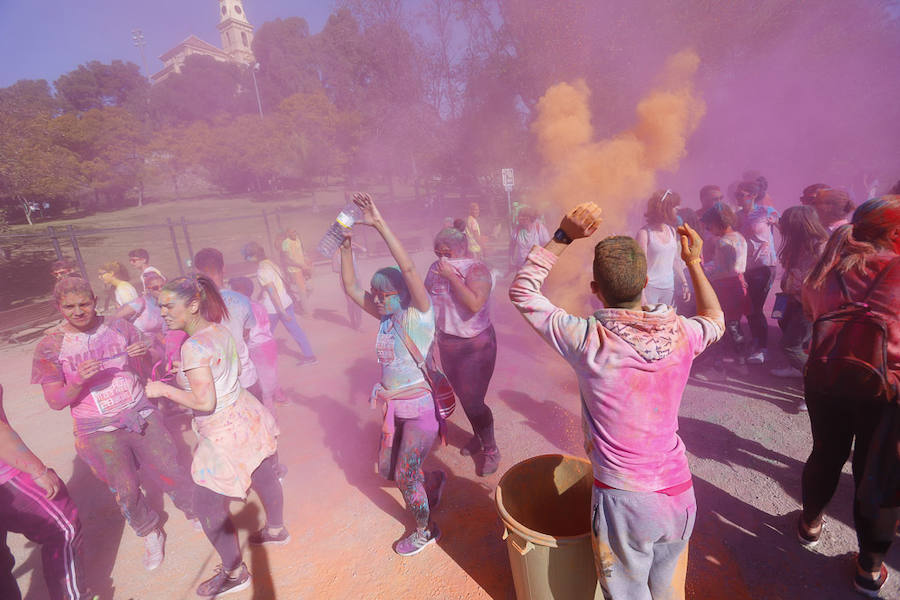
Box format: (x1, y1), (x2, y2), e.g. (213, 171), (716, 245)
(425, 227), (500, 477)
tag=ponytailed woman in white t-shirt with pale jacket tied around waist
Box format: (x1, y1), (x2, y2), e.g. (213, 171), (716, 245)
(147, 275), (290, 597)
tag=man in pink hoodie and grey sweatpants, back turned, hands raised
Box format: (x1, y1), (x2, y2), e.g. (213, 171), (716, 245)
(509, 203), (725, 600)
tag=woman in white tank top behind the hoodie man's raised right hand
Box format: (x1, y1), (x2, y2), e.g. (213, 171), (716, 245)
(634, 190), (690, 306)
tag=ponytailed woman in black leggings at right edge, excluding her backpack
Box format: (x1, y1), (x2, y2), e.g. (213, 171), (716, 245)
(798, 196), (900, 597)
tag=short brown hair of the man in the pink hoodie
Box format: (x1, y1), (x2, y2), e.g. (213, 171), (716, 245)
(594, 235), (647, 308)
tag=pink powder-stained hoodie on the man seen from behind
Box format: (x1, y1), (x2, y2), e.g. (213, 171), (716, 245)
(509, 246), (725, 492)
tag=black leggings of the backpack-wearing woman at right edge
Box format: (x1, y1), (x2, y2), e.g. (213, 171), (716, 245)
(802, 384), (898, 573)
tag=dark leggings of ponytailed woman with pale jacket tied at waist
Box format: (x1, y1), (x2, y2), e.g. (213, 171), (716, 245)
(194, 454), (284, 571)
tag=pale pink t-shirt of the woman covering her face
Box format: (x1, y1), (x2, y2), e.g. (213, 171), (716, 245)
(425, 258), (491, 338)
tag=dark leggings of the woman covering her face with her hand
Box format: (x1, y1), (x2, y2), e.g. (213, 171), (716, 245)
(437, 325), (497, 449)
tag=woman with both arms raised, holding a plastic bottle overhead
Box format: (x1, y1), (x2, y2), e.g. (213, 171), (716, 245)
(341, 194), (447, 556)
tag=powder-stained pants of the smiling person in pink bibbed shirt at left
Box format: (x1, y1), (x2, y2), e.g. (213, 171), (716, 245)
(75, 410), (194, 537)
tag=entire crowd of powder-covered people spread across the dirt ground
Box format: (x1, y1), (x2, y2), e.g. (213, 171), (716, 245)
(0, 174), (900, 600)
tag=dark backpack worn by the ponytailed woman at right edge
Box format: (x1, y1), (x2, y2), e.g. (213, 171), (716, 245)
(804, 259), (900, 402)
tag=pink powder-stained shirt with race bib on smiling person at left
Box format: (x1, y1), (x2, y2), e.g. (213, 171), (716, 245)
(31, 317), (144, 433)
